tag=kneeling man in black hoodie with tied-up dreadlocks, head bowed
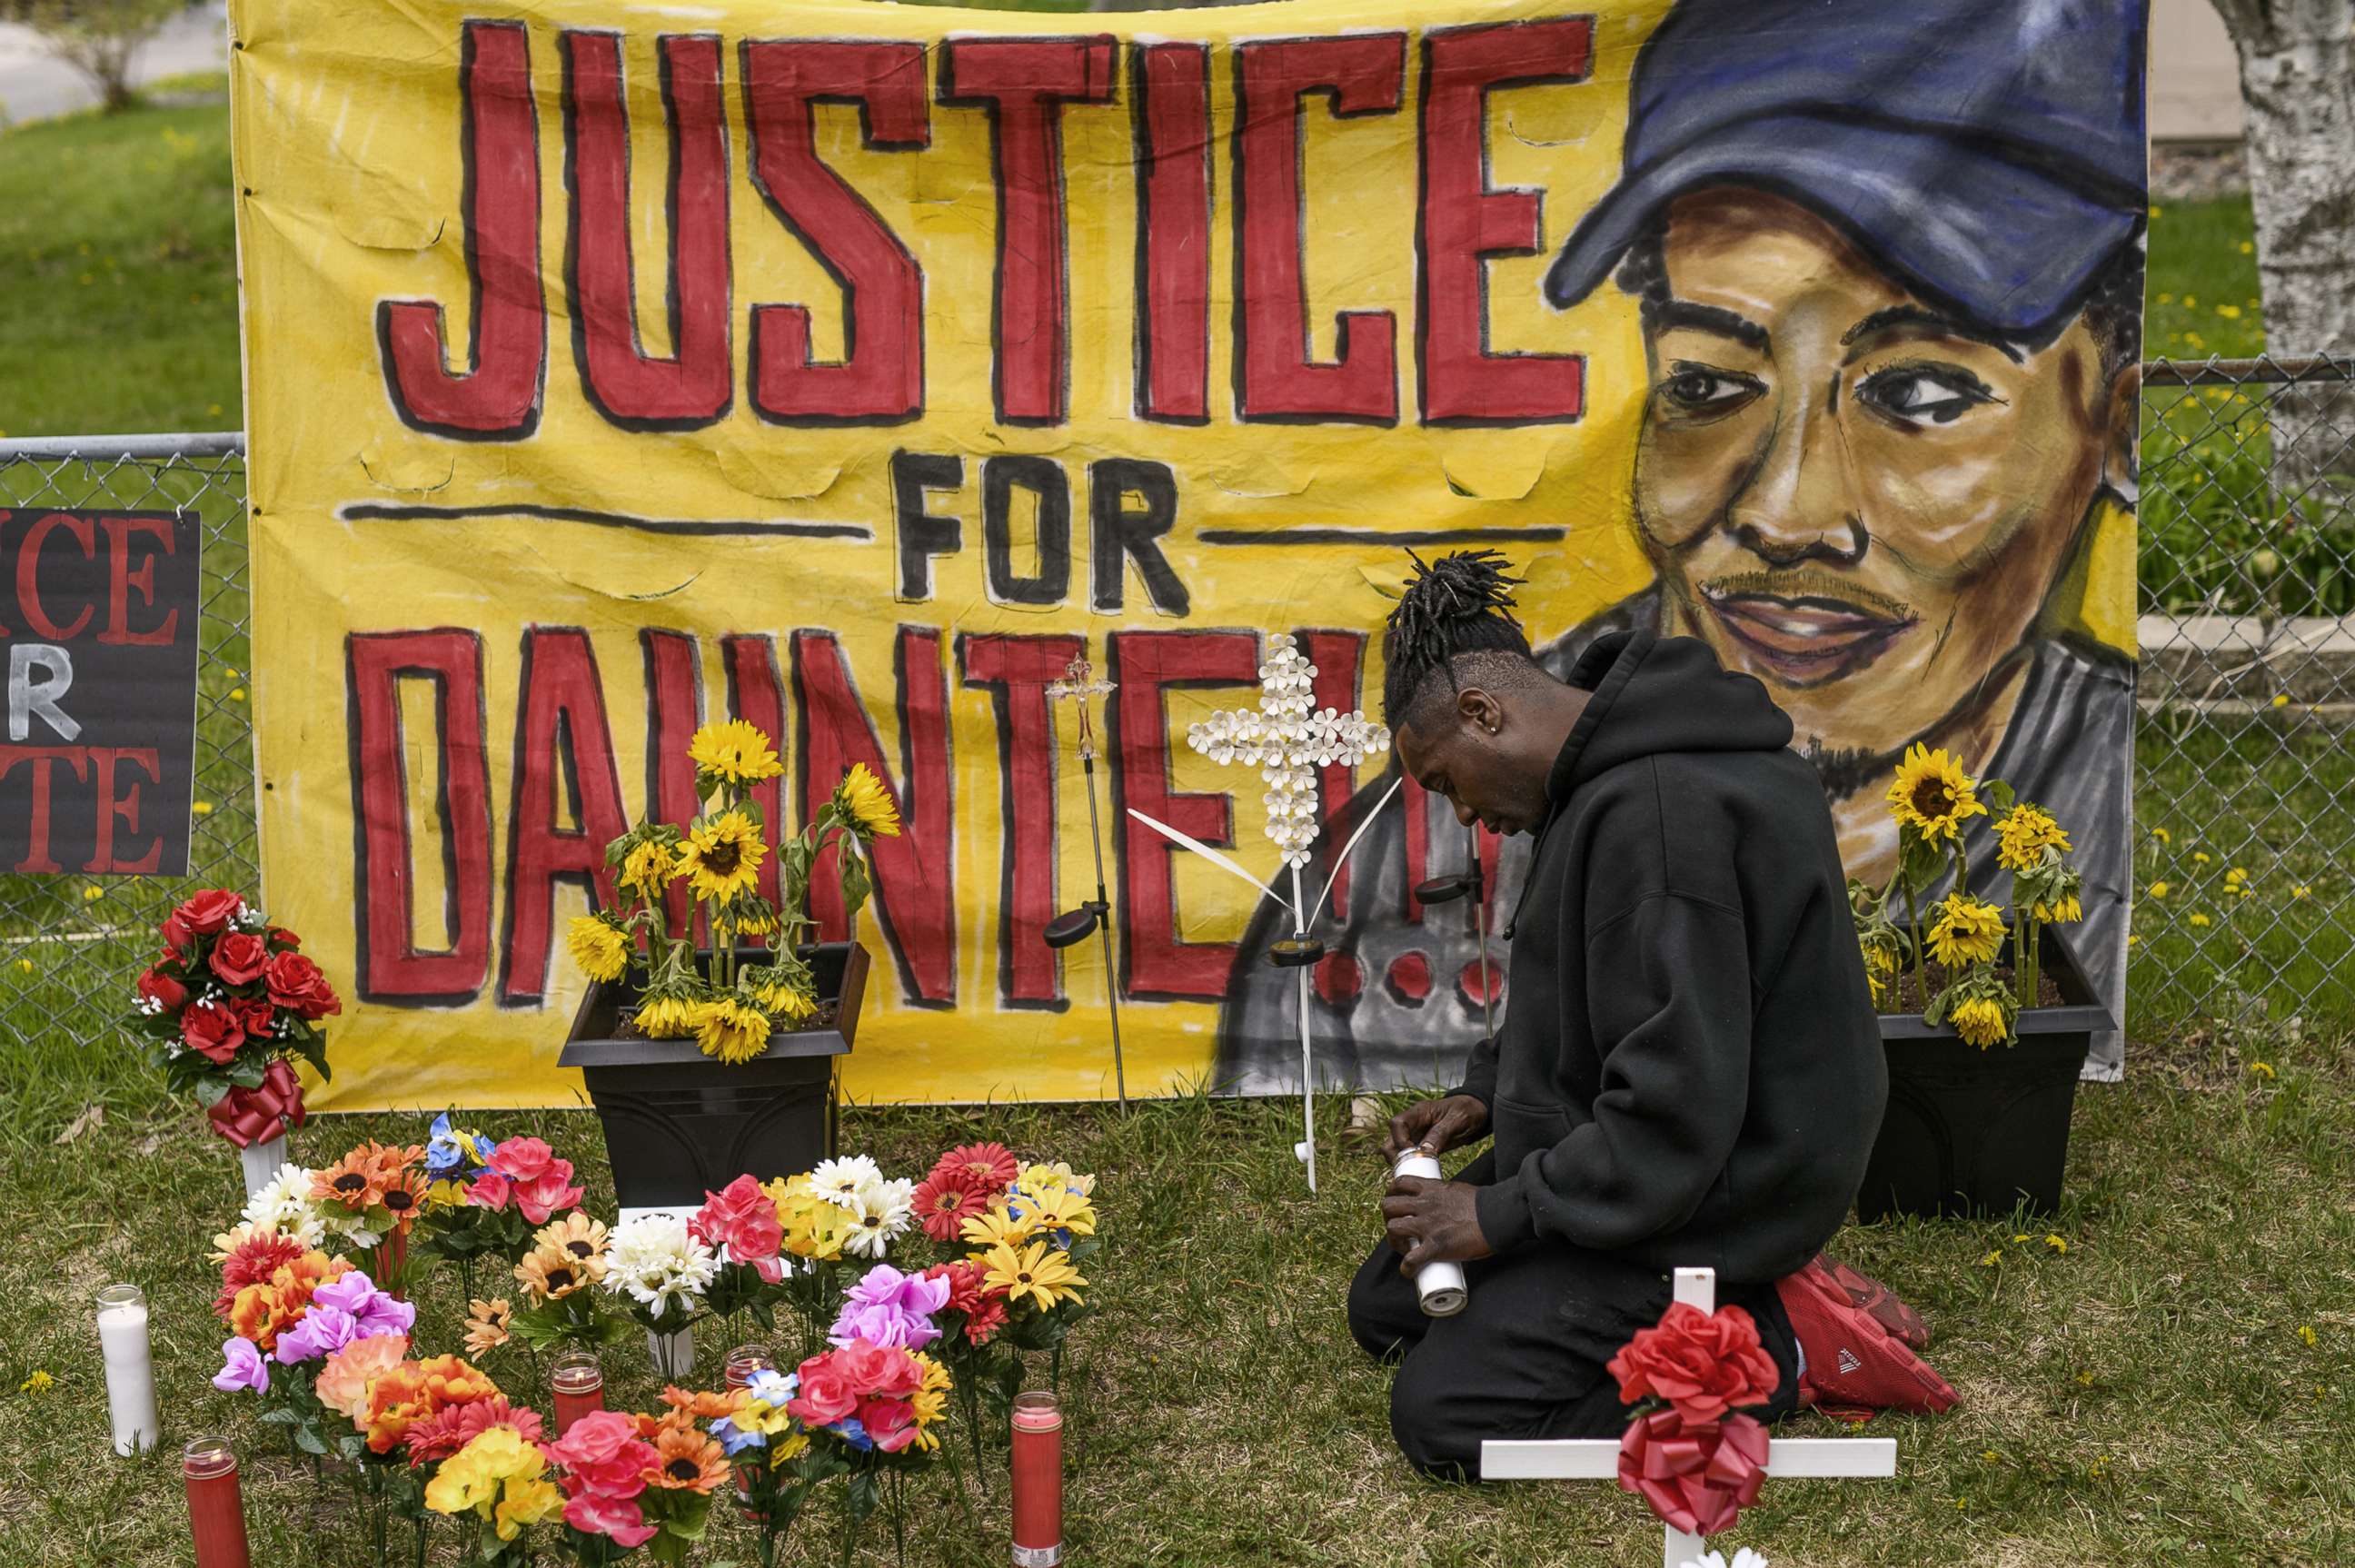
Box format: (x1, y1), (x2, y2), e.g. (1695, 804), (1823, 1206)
(1349, 551), (1886, 1474)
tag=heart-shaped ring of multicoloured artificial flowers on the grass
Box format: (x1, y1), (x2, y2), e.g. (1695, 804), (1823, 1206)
(197, 1116), (1099, 1568)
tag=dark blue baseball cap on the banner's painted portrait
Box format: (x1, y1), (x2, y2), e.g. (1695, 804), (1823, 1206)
(1545, 0), (2148, 339)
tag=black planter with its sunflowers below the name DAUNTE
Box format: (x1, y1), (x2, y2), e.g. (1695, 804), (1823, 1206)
(558, 720), (899, 1207)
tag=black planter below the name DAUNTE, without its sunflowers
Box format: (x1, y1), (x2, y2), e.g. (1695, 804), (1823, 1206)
(558, 942), (867, 1207)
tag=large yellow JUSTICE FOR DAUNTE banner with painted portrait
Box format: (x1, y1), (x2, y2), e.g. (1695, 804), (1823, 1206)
(234, 0), (2143, 1109)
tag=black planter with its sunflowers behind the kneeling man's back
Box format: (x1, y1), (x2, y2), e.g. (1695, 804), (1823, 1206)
(1849, 747), (2115, 1222)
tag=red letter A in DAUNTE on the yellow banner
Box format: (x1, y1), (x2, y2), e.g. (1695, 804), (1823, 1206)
(500, 626), (629, 1006)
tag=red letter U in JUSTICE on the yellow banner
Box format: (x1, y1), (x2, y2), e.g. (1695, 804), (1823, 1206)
(562, 31), (735, 431)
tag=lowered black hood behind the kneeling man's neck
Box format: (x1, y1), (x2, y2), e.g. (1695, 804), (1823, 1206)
(1545, 631), (1790, 810)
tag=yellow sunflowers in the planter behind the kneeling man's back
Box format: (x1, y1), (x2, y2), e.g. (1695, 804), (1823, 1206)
(1849, 744), (2084, 1050)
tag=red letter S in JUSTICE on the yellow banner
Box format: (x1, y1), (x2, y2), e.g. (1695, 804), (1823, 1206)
(744, 40), (932, 423)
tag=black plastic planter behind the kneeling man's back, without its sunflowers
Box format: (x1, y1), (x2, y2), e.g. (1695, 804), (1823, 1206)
(1855, 930), (2115, 1225)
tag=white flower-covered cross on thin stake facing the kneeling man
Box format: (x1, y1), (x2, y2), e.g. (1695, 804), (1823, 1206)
(1128, 631), (1399, 1191)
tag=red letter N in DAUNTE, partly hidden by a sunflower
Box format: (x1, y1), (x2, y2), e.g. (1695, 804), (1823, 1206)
(794, 626), (956, 1007)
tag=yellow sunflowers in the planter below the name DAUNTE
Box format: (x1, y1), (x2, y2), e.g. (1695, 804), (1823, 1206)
(568, 718), (899, 1062)
